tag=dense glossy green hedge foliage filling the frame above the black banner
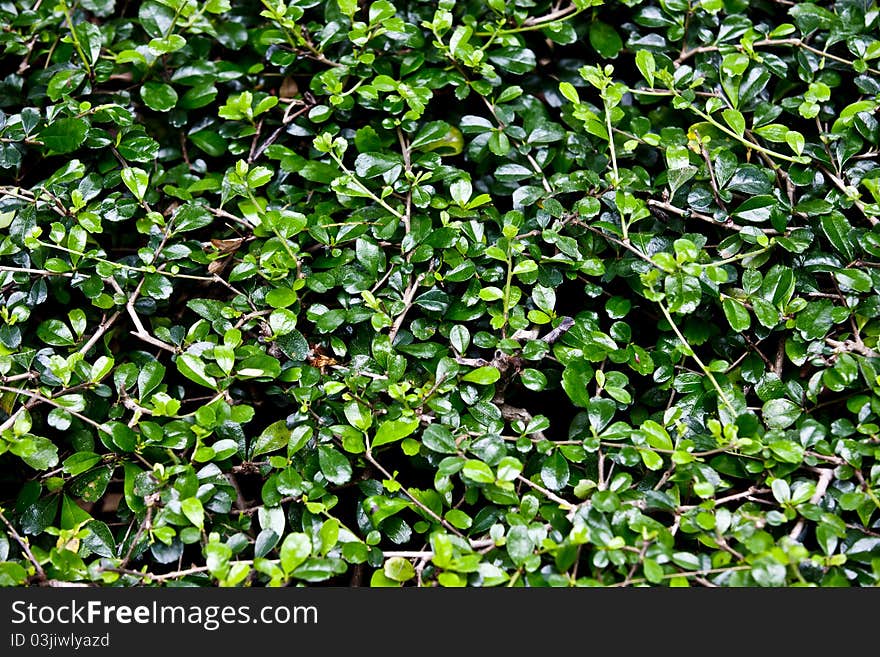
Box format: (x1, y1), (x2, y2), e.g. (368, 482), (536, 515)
(0, 0), (880, 587)
